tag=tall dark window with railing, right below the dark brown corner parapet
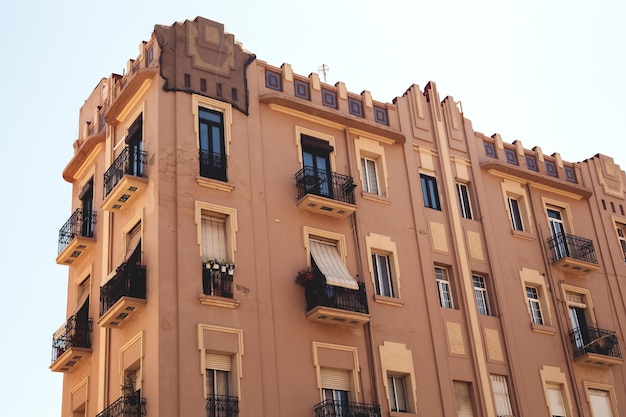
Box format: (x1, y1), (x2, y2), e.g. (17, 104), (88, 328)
(198, 107), (227, 181)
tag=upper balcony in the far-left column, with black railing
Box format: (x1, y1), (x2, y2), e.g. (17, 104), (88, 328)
(57, 209), (96, 265)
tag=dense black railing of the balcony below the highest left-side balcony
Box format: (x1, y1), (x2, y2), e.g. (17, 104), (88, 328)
(100, 263), (146, 317)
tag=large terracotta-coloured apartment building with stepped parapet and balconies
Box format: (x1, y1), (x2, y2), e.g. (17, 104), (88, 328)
(50, 17), (626, 417)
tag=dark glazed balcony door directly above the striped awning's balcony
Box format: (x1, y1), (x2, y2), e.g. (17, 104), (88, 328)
(302, 135), (333, 198)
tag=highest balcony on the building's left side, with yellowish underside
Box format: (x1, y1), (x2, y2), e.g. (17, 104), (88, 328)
(102, 147), (148, 211)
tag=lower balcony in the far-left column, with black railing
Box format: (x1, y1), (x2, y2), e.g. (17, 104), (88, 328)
(50, 315), (92, 372)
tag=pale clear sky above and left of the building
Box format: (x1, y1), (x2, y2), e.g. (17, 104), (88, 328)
(0, 0), (626, 417)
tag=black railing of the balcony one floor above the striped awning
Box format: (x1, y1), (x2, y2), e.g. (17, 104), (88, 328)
(296, 166), (356, 204)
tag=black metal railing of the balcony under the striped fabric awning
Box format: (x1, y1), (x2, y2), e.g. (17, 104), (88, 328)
(303, 271), (369, 314)
